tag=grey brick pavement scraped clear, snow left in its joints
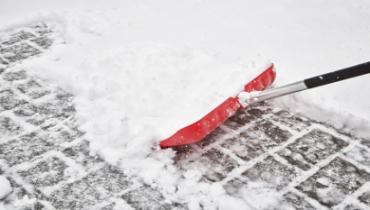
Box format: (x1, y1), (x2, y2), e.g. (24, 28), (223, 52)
(0, 23), (370, 210)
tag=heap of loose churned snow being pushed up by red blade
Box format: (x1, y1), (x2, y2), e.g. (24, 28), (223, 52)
(23, 19), (271, 166)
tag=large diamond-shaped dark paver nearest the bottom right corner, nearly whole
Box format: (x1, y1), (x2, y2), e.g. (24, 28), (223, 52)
(296, 158), (370, 208)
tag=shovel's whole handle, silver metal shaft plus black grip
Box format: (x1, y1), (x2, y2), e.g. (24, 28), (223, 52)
(243, 62), (370, 106)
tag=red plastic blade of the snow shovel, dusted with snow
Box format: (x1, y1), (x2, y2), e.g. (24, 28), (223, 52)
(159, 64), (276, 148)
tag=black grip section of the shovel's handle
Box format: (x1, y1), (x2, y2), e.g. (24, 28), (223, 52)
(304, 62), (370, 88)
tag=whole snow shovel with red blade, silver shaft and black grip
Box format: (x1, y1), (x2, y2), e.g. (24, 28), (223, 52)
(160, 62), (370, 148)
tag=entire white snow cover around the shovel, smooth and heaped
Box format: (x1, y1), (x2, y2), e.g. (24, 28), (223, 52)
(0, 0), (370, 209)
